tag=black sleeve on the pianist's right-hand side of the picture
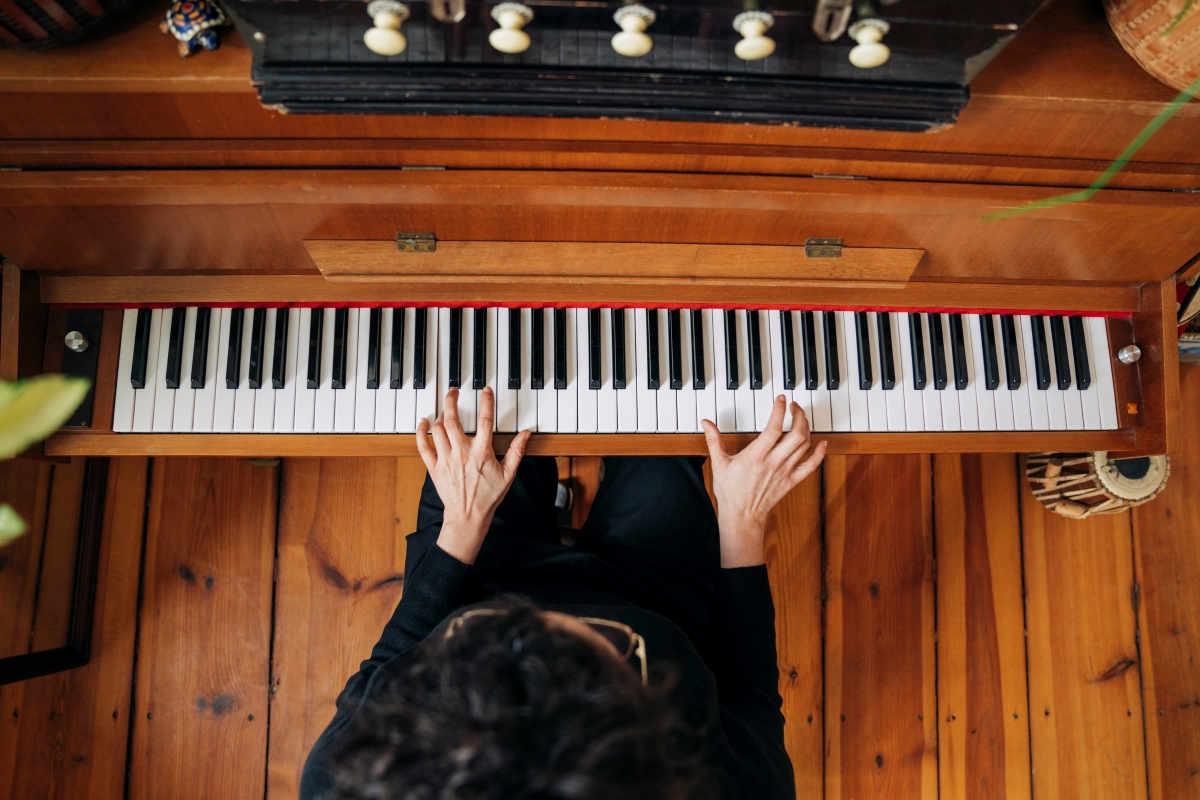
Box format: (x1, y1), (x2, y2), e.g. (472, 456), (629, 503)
(713, 566), (796, 800)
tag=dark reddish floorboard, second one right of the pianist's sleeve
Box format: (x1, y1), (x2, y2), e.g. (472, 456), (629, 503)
(824, 456), (937, 800)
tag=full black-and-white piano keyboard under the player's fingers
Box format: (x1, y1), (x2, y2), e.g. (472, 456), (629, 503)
(113, 307), (1117, 433)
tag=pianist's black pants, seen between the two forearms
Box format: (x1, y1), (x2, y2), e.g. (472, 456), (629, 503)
(404, 457), (720, 655)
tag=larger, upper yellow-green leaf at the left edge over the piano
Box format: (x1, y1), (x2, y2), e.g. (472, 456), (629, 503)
(0, 375), (90, 458)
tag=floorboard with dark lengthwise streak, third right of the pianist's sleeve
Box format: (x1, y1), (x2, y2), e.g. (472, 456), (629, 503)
(934, 453), (1030, 800)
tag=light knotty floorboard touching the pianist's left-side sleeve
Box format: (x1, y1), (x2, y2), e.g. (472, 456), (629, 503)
(268, 458), (425, 800)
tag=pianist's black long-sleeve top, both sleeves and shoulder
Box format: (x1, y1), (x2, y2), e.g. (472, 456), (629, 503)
(300, 546), (796, 800)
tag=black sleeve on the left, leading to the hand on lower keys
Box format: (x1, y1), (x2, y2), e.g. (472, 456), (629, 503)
(300, 546), (470, 800)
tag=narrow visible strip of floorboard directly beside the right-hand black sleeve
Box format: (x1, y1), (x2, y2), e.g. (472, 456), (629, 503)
(766, 475), (824, 798)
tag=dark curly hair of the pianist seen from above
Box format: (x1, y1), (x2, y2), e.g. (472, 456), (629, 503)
(332, 597), (716, 800)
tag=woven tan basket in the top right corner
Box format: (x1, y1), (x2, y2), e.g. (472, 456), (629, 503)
(1104, 0), (1200, 91)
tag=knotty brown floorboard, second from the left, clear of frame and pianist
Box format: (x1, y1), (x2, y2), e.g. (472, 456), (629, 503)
(128, 458), (277, 800)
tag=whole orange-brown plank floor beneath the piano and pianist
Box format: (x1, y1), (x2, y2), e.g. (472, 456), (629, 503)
(0, 368), (1200, 800)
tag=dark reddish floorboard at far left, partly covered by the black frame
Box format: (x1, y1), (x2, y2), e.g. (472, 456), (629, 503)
(0, 458), (148, 800)
